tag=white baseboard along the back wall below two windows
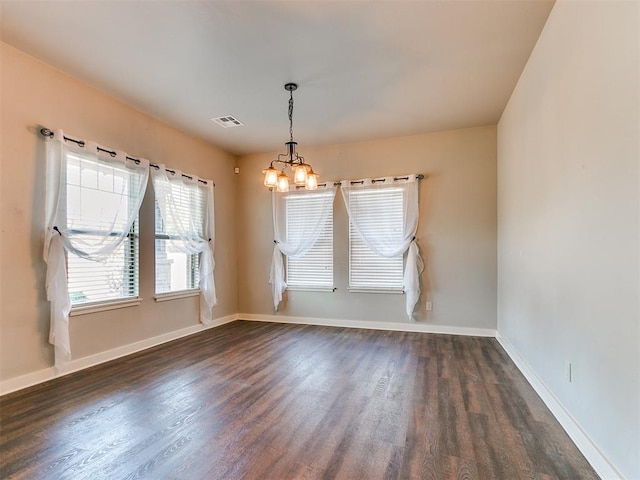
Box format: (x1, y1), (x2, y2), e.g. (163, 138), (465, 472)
(238, 313), (496, 337)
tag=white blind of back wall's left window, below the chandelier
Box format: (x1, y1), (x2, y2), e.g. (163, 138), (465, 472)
(285, 192), (333, 289)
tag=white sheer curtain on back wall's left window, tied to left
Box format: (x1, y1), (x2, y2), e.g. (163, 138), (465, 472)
(269, 184), (336, 311)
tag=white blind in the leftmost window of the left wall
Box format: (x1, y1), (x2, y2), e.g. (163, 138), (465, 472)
(66, 153), (139, 305)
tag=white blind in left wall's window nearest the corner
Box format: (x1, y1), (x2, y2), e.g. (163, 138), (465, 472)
(155, 182), (206, 294)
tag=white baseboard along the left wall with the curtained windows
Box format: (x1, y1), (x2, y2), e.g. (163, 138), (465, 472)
(0, 314), (238, 395)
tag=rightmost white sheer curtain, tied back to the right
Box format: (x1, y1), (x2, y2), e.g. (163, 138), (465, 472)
(340, 175), (424, 318)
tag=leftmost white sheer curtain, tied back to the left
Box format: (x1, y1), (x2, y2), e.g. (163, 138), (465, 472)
(44, 130), (149, 369)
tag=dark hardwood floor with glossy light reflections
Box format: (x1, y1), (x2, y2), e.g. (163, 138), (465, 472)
(0, 321), (598, 480)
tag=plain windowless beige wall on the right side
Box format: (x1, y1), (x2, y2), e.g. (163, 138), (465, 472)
(498, 0), (640, 479)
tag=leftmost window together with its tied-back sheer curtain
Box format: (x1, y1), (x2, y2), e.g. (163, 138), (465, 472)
(46, 128), (149, 368)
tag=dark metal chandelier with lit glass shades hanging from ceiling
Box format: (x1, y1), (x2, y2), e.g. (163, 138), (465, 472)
(262, 83), (319, 192)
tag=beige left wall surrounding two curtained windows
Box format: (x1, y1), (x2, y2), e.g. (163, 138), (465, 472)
(0, 44), (238, 380)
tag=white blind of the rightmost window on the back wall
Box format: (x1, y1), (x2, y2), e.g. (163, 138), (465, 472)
(349, 188), (404, 291)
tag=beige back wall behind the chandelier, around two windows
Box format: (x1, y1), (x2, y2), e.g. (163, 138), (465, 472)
(238, 126), (496, 329)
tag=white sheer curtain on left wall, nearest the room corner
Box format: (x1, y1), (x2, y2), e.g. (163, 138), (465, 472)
(151, 164), (218, 324)
